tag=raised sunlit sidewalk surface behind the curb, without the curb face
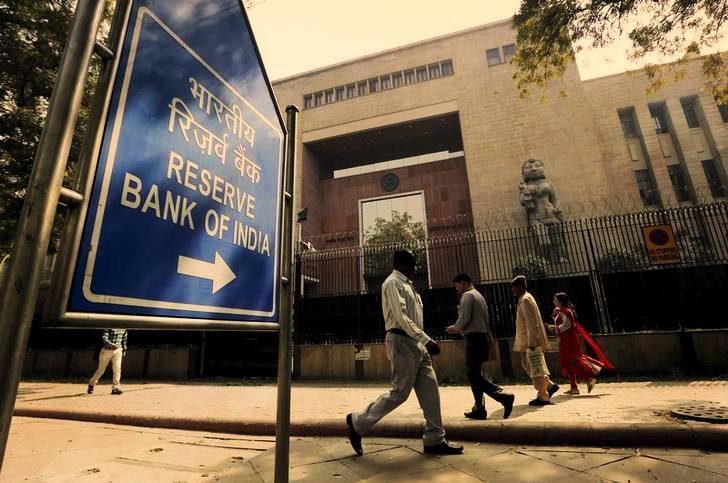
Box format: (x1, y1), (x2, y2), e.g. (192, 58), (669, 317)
(16, 380), (728, 423)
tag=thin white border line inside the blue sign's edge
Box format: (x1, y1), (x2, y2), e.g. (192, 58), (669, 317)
(83, 7), (283, 317)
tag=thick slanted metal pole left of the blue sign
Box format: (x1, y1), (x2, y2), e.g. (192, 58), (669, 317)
(0, 0), (105, 470)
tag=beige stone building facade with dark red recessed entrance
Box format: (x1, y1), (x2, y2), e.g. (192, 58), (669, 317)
(273, 20), (728, 249)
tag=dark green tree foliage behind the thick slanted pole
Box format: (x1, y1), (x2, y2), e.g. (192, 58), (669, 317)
(0, 0), (109, 256)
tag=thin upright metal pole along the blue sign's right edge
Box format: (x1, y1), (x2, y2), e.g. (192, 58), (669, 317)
(275, 106), (299, 483)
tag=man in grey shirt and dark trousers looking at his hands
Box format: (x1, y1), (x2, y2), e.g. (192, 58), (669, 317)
(447, 273), (515, 419)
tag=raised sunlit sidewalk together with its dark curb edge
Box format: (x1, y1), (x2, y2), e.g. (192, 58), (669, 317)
(15, 381), (728, 450)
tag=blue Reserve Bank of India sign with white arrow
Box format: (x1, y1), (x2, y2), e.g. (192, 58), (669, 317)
(67, 0), (284, 322)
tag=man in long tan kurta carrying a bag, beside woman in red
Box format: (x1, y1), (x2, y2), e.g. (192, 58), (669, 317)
(511, 275), (559, 406)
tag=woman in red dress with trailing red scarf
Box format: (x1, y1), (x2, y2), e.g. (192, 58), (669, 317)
(547, 292), (614, 395)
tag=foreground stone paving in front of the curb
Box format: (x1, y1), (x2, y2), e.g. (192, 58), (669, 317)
(0, 417), (728, 483)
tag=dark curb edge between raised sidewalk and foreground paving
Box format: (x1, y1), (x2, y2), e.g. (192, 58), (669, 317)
(13, 407), (728, 451)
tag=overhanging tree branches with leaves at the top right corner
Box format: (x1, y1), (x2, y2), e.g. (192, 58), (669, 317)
(512, 0), (728, 103)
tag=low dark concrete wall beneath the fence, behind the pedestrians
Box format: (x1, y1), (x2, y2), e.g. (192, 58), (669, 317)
(23, 330), (728, 381)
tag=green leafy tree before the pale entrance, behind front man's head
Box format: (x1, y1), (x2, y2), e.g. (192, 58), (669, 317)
(364, 211), (426, 277)
